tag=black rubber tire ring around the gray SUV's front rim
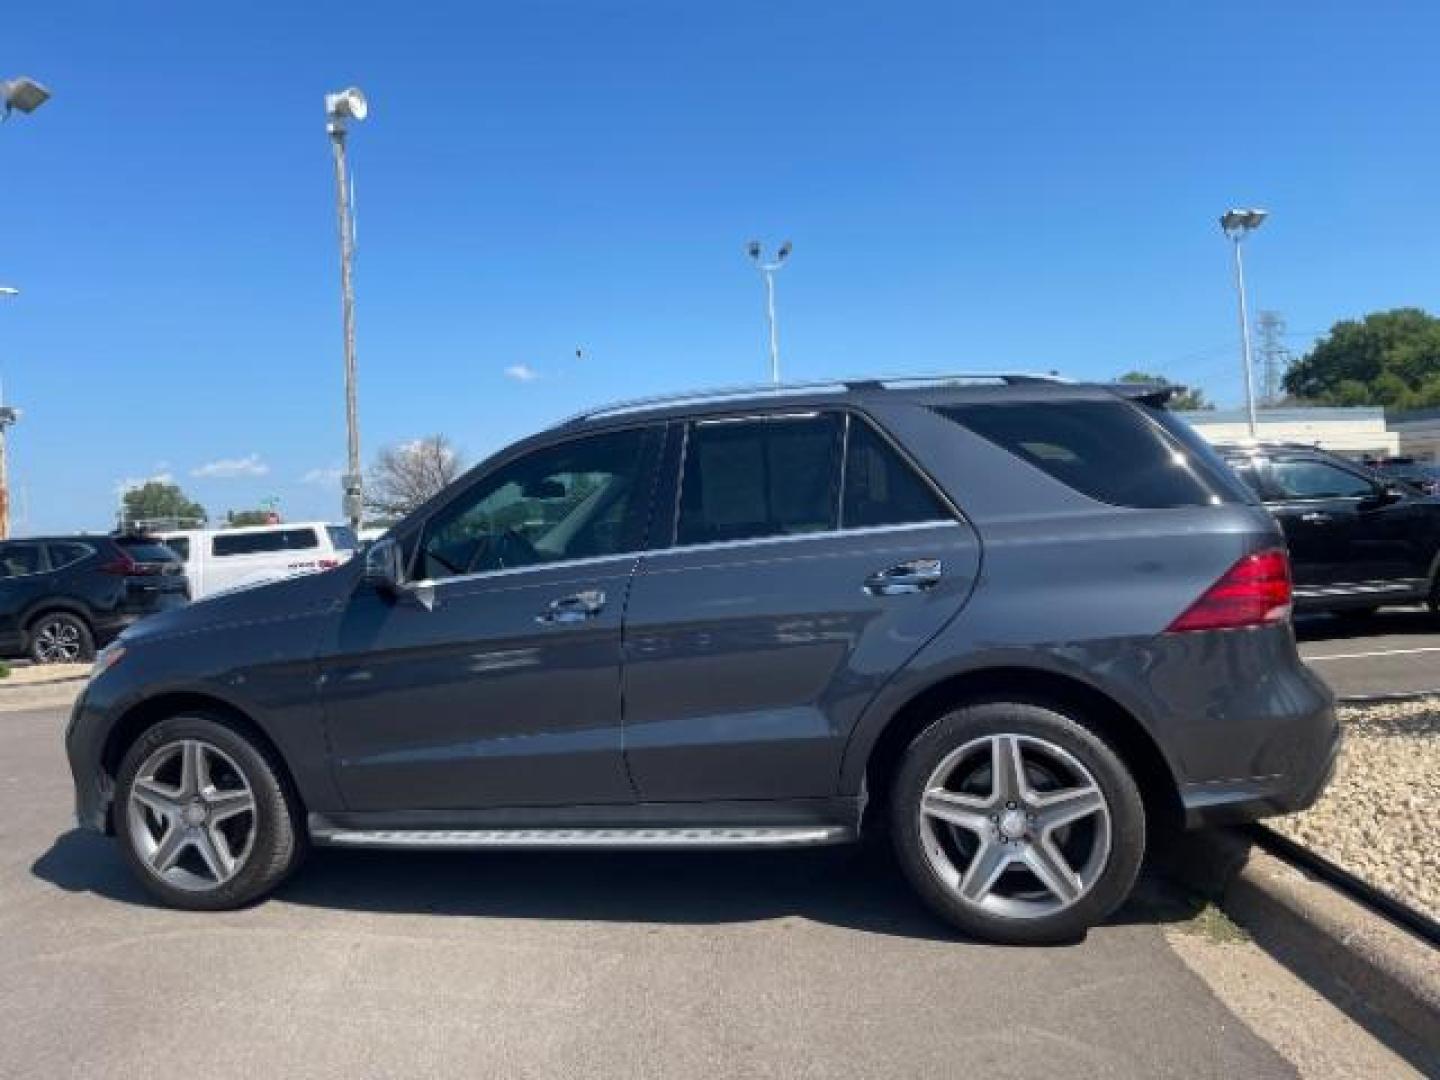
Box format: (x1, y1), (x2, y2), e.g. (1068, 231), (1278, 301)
(112, 714), (308, 912)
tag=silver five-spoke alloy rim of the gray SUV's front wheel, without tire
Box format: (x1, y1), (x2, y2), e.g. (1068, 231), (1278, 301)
(127, 739), (255, 891)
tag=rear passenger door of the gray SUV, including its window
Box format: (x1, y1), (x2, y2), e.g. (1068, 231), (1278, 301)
(624, 412), (979, 801)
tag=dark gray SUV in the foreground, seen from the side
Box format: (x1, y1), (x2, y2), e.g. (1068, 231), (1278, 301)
(66, 376), (1338, 942)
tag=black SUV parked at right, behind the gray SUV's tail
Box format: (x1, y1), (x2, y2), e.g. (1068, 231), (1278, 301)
(1220, 442), (1440, 613)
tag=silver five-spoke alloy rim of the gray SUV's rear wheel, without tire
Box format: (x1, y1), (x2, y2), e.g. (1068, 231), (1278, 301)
(919, 734), (1112, 919)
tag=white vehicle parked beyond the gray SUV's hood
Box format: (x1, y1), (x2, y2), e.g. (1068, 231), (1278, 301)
(156, 521), (359, 599)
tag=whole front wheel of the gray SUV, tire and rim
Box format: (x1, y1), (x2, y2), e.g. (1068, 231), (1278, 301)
(115, 716), (304, 912)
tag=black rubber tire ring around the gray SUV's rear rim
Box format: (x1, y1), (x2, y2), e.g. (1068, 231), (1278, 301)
(890, 701), (1146, 945)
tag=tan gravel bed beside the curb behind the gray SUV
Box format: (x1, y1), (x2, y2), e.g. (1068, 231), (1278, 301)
(1266, 697), (1440, 919)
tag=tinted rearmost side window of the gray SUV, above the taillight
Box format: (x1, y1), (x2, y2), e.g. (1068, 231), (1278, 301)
(940, 400), (1248, 508)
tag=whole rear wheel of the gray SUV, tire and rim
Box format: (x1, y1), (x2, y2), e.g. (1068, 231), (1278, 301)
(891, 701), (1145, 945)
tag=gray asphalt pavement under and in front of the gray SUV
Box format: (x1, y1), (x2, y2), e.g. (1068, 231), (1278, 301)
(0, 706), (1295, 1080)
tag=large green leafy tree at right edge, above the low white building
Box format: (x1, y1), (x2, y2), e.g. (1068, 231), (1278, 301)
(1284, 308), (1440, 409)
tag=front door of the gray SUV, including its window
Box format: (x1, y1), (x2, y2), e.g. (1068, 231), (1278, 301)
(321, 428), (661, 811)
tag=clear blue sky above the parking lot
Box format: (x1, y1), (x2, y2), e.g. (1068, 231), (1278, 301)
(0, 0), (1440, 531)
